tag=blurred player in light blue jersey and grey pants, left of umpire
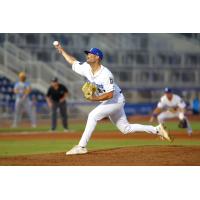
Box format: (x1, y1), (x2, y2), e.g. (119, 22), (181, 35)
(12, 72), (36, 128)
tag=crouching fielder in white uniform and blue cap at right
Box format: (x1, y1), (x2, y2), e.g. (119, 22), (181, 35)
(150, 88), (192, 136)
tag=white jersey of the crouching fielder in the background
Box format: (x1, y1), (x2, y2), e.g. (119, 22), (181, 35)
(157, 94), (186, 110)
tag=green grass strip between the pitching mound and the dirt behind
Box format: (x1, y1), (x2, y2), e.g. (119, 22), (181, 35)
(0, 139), (200, 156)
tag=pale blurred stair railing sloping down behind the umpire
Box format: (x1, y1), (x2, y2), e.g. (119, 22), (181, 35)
(0, 42), (83, 100)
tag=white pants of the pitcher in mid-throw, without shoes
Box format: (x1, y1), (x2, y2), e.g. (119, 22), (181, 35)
(79, 102), (157, 147)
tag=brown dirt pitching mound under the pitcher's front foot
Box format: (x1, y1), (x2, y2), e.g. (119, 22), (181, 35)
(0, 146), (200, 166)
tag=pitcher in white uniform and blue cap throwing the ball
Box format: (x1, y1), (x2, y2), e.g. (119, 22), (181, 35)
(54, 43), (171, 155)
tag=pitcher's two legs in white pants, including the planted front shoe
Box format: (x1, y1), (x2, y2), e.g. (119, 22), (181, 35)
(66, 103), (171, 155)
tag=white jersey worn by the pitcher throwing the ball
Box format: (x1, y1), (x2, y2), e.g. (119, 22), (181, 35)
(72, 61), (124, 103)
